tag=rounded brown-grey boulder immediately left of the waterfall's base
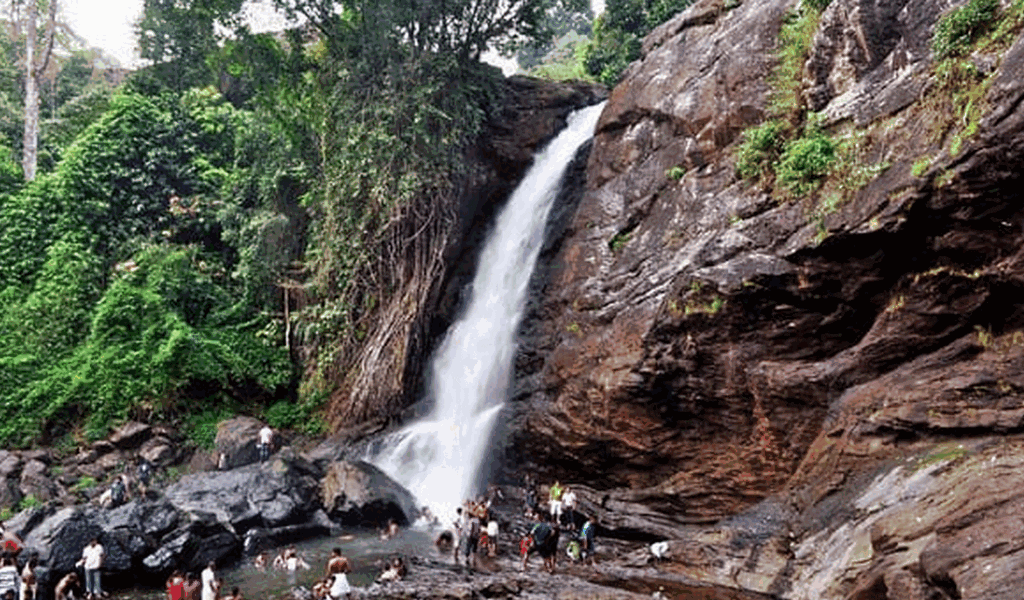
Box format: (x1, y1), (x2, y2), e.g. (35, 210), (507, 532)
(321, 461), (418, 527)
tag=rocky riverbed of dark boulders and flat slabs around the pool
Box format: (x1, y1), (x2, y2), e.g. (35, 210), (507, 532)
(0, 418), (765, 600)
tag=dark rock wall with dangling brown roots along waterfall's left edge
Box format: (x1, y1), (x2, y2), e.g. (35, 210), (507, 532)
(329, 77), (607, 430)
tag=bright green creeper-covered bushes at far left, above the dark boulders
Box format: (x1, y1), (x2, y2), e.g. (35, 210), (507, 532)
(0, 90), (293, 443)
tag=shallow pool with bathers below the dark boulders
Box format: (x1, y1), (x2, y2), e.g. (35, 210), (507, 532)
(112, 529), (436, 600)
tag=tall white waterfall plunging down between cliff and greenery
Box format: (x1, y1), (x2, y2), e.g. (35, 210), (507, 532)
(369, 103), (604, 515)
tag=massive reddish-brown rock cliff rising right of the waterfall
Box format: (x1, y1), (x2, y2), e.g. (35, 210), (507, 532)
(506, 0), (1024, 600)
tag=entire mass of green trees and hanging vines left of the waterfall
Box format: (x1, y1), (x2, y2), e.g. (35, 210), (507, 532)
(0, 0), (584, 444)
